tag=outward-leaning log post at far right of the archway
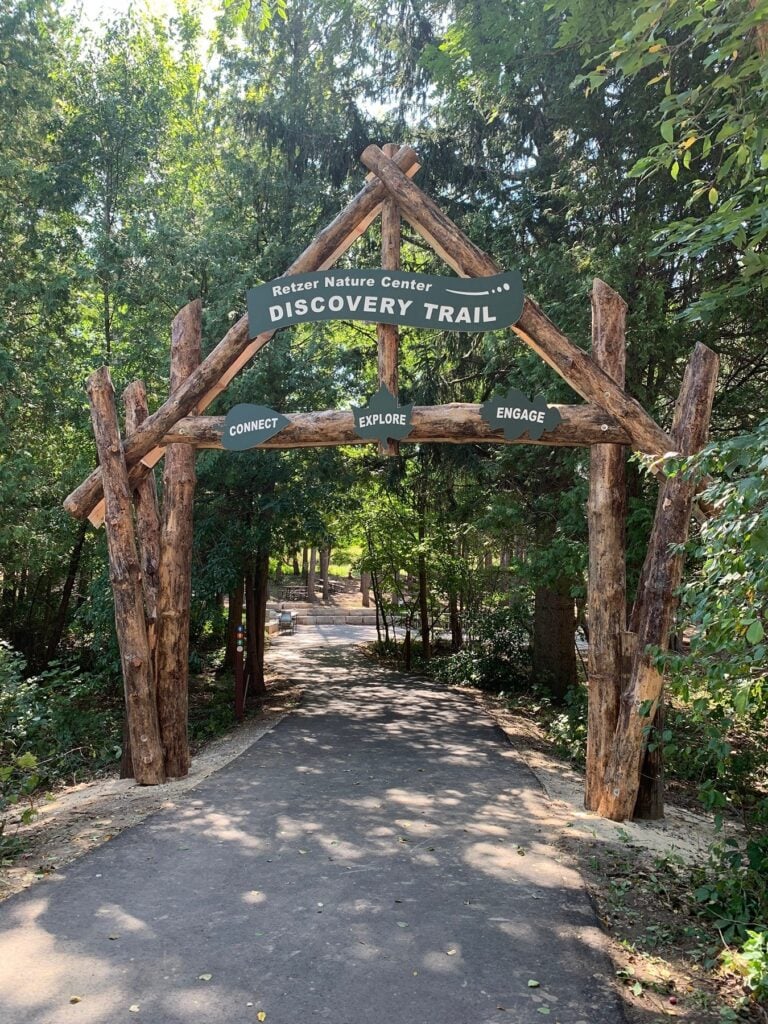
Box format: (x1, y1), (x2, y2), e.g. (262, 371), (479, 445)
(598, 344), (718, 821)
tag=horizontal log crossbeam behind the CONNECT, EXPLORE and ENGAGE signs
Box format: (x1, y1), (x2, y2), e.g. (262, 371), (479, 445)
(160, 402), (631, 448)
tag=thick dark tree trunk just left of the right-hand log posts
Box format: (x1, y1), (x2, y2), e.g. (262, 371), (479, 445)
(534, 582), (578, 699)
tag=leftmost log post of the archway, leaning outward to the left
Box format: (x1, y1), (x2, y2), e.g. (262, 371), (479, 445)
(87, 367), (165, 785)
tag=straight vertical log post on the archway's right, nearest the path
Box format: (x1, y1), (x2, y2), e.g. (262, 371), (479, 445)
(584, 278), (627, 811)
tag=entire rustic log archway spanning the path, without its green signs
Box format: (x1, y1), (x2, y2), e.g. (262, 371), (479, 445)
(65, 145), (718, 820)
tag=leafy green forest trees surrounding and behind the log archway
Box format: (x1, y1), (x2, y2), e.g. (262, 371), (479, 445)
(0, 0), (768, 1007)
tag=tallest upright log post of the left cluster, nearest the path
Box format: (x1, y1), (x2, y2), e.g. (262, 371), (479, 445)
(156, 299), (203, 778)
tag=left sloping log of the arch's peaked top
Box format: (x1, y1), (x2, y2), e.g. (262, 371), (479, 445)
(63, 146), (419, 519)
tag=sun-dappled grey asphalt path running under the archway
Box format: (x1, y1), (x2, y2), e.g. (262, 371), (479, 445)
(0, 628), (624, 1024)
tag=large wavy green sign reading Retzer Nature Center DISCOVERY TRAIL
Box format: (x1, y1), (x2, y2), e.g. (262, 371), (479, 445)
(248, 269), (523, 338)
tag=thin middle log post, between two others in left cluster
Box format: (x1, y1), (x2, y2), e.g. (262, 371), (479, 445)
(123, 381), (160, 651)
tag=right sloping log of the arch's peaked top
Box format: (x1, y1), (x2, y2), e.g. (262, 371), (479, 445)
(360, 145), (672, 456)
